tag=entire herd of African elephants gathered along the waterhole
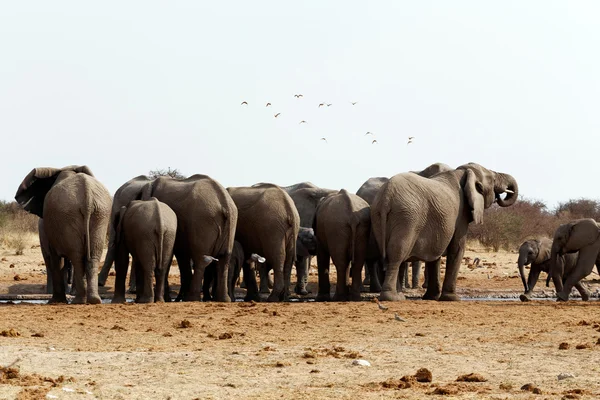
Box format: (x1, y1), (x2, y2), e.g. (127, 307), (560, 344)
(15, 163), (600, 303)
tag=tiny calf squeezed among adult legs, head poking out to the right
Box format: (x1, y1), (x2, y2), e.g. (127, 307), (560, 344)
(202, 240), (266, 301)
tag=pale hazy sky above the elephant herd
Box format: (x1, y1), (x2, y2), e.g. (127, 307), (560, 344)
(0, 0), (600, 206)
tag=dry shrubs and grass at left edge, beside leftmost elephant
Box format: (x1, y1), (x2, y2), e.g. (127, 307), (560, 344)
(0, 202), (38, 255)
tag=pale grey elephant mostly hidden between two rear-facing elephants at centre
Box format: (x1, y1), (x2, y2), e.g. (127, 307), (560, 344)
(254, 182), (336, 295)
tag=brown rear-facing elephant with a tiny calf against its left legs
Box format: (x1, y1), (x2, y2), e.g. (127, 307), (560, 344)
(227, 183), (300, 301)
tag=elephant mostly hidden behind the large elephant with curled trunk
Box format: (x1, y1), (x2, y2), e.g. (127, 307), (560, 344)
(356, 163), (452, 293)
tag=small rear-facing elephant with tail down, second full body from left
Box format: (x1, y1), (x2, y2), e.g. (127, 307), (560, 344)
(112, 197), (177, 303)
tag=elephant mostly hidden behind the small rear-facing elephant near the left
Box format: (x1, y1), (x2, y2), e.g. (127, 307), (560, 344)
(98, 175), (152, 293)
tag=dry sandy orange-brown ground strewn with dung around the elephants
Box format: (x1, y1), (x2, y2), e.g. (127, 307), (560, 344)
(0, 242), (600, 399)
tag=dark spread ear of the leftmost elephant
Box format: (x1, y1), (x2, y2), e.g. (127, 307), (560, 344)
(15, 168), (62, 218)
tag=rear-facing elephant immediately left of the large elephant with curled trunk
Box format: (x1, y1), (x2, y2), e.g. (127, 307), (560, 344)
(314, 189), (371, 301)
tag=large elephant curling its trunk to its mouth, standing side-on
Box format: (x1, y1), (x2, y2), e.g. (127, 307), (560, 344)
(371, 163), (519, 301)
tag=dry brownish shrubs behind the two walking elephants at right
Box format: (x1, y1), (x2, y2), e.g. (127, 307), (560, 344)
(469, 197), (600, 251)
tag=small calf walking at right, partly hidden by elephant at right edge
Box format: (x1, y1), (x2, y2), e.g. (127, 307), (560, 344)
(517, 238), (600, 301)
